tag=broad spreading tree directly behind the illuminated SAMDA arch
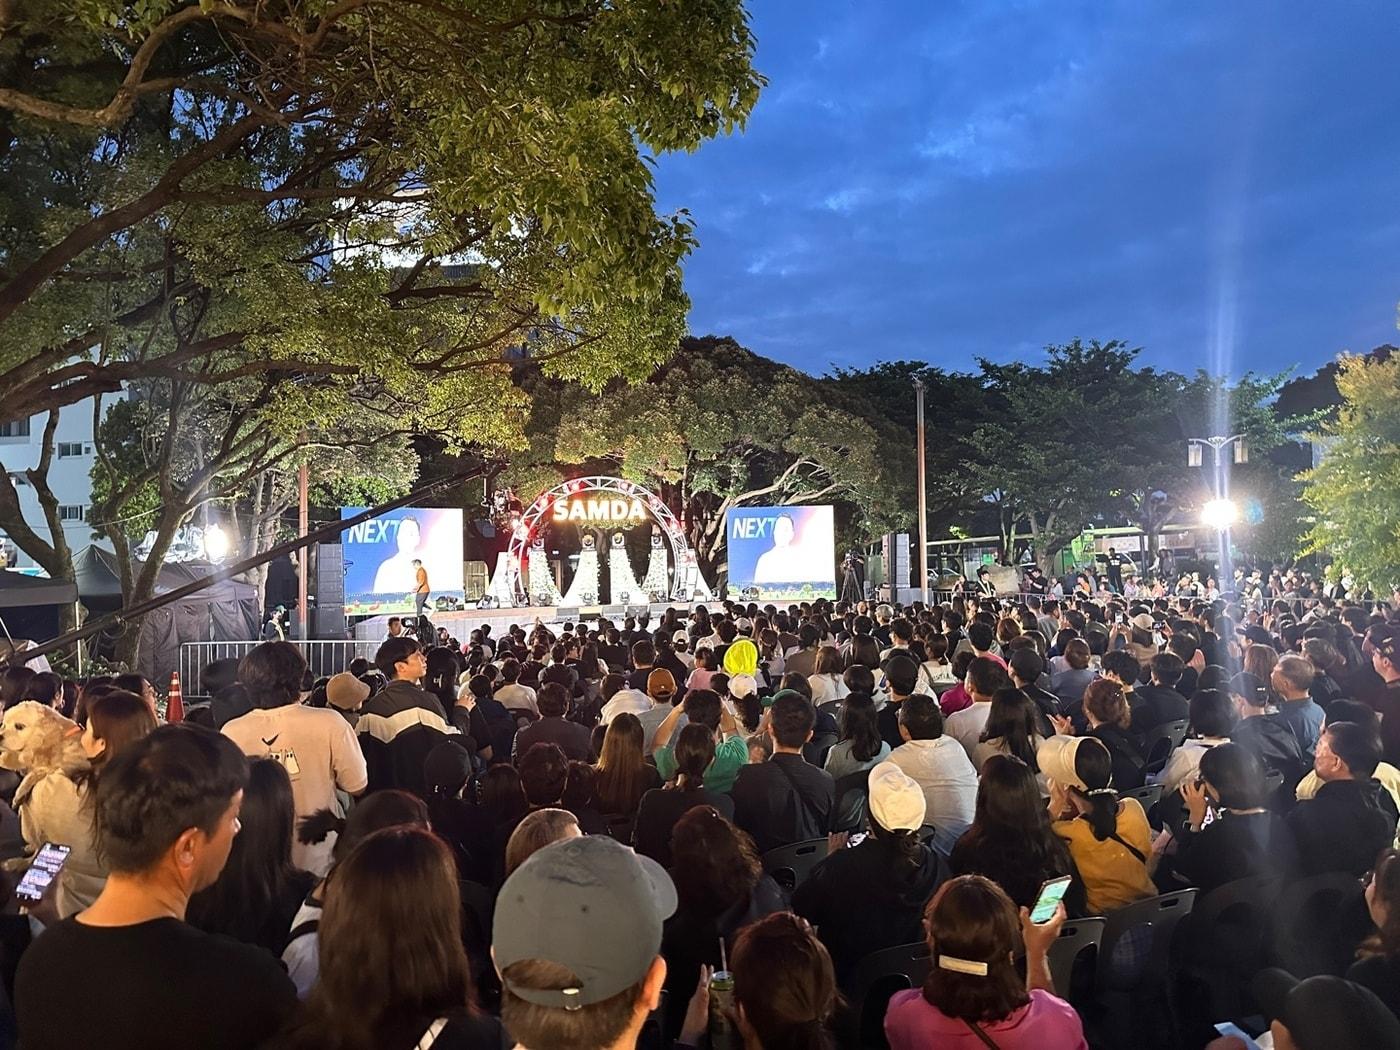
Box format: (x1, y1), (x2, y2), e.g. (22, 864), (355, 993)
(507, 337), (890, 578)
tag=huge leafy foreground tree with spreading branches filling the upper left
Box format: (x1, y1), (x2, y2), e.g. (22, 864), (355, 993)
(0, 0), (762, 658)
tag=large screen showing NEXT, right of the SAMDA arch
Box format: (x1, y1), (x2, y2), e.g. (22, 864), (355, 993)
(724, 507), (836, 602)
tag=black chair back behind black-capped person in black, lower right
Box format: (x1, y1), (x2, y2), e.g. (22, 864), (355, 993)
(1172, 875), (1282, 1046)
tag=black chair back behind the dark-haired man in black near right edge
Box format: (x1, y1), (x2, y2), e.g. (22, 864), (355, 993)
(1273, 871), (1371, 980)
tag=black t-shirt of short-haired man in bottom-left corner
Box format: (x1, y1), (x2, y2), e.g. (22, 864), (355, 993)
(14, 918), (297, 1050)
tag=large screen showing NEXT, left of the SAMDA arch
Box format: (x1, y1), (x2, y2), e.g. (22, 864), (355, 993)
(340, 507), (463, 616)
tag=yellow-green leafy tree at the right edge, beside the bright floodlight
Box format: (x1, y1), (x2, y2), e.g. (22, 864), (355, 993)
(1303, 356), (1400, 594)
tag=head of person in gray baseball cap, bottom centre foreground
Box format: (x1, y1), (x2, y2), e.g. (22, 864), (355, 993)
(491, 836), (676, 1050)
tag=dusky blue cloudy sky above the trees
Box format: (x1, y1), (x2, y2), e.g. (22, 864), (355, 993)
(657, 0), (1400, 372)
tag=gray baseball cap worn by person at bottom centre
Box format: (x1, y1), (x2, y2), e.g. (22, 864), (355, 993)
(491, 836), (676, 1009)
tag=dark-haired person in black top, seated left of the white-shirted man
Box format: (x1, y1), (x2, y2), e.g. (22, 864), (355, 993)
(729, 689), (836, 853)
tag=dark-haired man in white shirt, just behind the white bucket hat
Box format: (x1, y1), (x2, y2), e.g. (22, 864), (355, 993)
(889, 693), (977, 855)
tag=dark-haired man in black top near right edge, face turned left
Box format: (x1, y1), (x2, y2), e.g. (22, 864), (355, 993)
(1288, 722), (1397, 876)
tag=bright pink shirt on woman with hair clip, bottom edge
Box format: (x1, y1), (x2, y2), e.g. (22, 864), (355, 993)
(885, 988), (1089, 1050)
